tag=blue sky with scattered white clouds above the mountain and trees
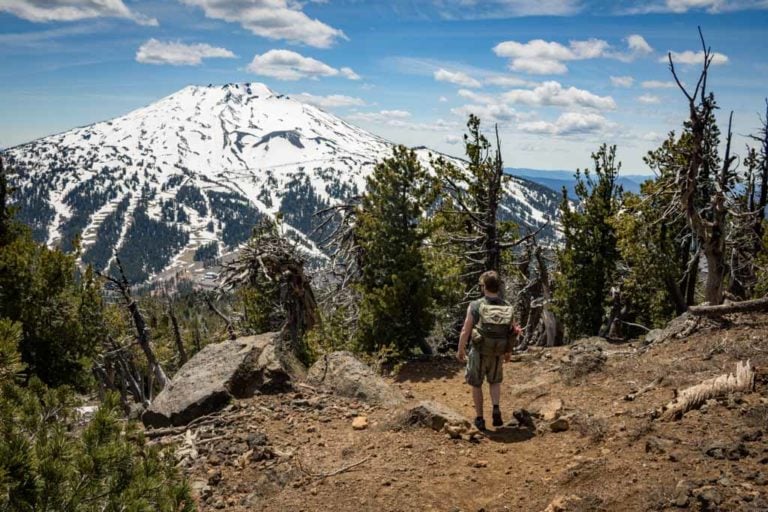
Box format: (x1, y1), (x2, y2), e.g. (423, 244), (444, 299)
(0, 0), (768, 173)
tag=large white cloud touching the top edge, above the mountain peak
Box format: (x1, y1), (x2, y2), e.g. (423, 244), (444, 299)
(180, 0), (347, 48)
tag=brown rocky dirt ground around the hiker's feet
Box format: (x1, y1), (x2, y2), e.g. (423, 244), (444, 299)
(149, 315), (768, 512)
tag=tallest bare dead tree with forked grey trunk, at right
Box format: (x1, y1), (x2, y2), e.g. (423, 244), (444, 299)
(668, 29), (736, 304)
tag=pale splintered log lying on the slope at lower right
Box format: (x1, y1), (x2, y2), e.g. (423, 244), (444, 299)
(657, 360), (755, 420)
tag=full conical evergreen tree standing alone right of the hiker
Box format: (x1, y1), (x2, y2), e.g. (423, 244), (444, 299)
(555, 144), (622, 337)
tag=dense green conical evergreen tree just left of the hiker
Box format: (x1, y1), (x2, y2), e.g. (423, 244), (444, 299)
(355, 146), (434, 355)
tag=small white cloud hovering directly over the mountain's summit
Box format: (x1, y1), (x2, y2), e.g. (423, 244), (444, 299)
(246, 50), (360, 80)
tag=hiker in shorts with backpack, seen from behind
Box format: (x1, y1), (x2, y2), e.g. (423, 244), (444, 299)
(457, 271), (520, 430)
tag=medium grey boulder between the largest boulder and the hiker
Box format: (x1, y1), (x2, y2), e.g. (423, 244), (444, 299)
(307, 352), (405, 407)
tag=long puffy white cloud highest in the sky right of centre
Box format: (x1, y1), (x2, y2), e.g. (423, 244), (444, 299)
(493, 34), (653, 75)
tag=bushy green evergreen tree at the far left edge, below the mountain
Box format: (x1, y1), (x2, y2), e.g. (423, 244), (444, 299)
(0, 157), (102, 388)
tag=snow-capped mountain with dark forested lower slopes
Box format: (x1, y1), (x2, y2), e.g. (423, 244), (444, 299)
(4, 83), (559, 281)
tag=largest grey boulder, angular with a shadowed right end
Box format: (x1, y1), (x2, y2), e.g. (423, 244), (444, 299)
(141, 333), (290, 427)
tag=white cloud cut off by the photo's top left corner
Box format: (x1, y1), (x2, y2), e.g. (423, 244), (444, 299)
(0, 0), (158, 26)
